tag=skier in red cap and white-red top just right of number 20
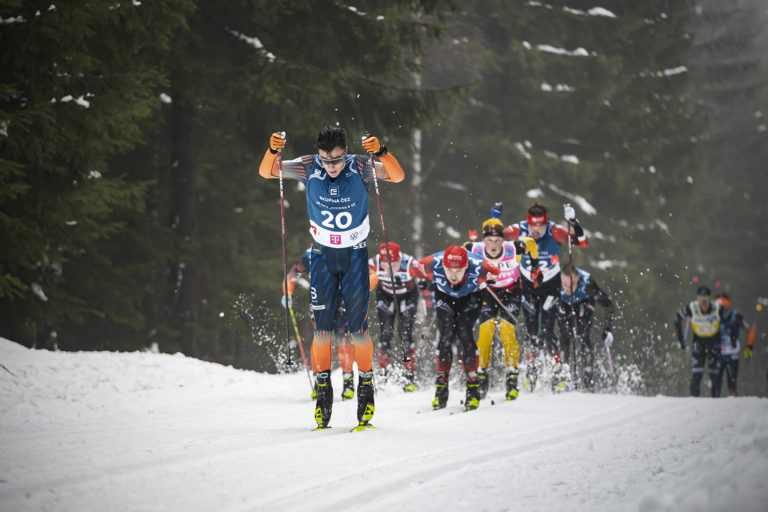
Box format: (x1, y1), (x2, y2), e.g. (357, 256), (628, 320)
(368, 242), (419, 391)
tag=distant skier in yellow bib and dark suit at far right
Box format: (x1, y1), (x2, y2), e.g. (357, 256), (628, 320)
(675, 286), (738, 397)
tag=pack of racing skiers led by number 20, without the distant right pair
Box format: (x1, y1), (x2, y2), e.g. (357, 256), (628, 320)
(259, 127), (624, 429)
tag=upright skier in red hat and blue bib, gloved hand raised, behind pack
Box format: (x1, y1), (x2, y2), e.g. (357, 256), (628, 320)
(504, 203), (589, 390)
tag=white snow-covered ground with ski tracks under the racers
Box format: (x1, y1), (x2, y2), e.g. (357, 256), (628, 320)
(0, 338), (768, 512)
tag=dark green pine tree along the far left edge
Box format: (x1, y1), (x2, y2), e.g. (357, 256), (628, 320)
(0, 2), (192, 346)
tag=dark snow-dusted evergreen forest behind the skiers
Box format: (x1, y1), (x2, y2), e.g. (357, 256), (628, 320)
(0, 0), (768, 396)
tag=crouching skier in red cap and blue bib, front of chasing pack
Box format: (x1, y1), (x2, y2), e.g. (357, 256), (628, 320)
(416, 245), (499, 411)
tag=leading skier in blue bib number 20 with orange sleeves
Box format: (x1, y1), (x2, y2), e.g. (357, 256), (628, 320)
(259, 126), (404, 429)
